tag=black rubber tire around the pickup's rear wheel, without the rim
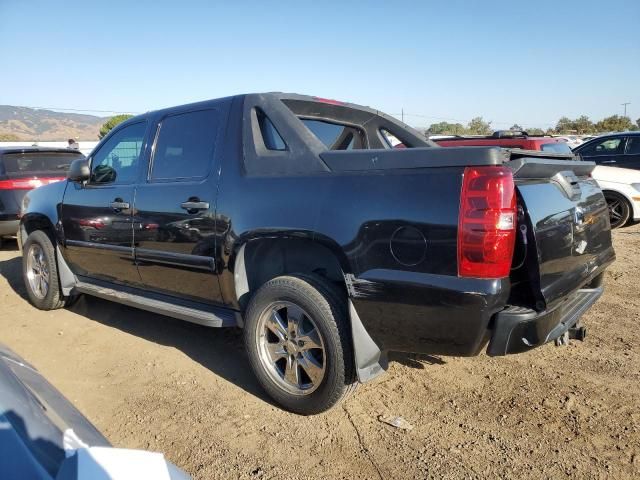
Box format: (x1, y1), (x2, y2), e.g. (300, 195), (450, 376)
(244, 274), (357, 415)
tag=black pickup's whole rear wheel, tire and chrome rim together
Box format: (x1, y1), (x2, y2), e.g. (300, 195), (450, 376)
(244, 274), (357, 415)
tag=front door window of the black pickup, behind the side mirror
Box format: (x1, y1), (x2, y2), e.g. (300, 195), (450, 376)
(90, 122), (147, 184)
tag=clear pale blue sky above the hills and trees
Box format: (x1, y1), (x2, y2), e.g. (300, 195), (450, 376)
(0, 0), (640, 128)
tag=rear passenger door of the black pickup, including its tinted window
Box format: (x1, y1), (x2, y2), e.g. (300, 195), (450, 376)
(134, 101), (228, 303)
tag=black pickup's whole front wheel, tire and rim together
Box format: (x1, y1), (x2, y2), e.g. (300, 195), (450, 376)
(22, 230), (65, 310)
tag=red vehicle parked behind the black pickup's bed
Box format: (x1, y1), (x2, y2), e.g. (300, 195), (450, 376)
(432, 130), (571, 153)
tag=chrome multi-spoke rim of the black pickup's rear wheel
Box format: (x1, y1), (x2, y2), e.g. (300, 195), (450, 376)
(256, 301), (326, 395)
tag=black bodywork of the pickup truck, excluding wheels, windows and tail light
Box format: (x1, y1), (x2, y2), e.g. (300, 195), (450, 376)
(21, 94), (614, 374)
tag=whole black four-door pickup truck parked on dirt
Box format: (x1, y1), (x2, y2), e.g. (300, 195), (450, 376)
(19, 93), (615, 414)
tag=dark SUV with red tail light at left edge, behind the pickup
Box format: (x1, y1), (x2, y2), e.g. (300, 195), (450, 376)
(0, 147), (84, 245)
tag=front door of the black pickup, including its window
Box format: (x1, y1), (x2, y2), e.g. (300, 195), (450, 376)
(62, 122), (147, 284)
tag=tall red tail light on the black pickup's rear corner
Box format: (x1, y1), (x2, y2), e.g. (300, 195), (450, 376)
(458, 167), (516, 278)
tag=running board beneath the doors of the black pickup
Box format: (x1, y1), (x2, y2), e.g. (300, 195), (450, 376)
(74, 280), (239, 327)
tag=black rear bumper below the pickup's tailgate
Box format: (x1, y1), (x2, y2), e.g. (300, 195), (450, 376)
(487, 286), (604, 356)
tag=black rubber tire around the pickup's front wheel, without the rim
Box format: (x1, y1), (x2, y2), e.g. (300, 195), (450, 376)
(22, 230), (65, 310)
